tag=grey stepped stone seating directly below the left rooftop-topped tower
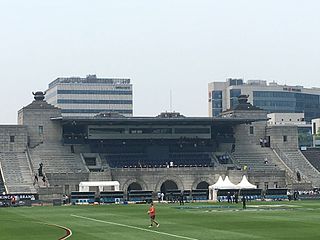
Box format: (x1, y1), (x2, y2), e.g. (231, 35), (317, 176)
(29, 143), (89, 173)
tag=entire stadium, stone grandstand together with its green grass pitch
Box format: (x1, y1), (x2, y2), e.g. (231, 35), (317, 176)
(0, 92), (320, 239)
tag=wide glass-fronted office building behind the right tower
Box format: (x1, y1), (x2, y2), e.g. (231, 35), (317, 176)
(208, 78), (320, 123)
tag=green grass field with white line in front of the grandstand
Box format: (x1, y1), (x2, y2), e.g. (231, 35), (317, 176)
(0, 201), (320, 240)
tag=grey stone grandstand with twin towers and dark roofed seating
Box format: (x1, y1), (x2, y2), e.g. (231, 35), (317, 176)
(0, 92), (320, 200)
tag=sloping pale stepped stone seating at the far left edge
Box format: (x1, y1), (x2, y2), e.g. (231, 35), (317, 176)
(0, 152), (37, 194)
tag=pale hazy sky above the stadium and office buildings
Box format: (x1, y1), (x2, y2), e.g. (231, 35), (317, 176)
(0, 0), (320, 124)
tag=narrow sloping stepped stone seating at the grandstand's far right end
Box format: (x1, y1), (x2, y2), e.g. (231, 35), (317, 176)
(277, 149), (320, 188)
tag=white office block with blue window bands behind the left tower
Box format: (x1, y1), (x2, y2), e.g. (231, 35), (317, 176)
(46, 75), (133, 117)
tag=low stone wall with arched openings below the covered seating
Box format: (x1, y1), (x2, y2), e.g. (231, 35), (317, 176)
(39, 168), (286, 199)
